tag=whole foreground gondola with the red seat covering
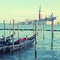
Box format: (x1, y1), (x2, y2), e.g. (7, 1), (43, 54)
(0, 34), (36, 52)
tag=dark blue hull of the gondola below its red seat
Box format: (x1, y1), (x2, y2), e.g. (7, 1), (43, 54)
(0, 35), (35, 53)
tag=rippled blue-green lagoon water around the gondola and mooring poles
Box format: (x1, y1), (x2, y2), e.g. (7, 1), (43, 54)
(0, 26), (60, 60)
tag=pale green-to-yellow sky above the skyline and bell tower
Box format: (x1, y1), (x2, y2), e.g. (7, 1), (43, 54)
(0, 0), (60, 23)
